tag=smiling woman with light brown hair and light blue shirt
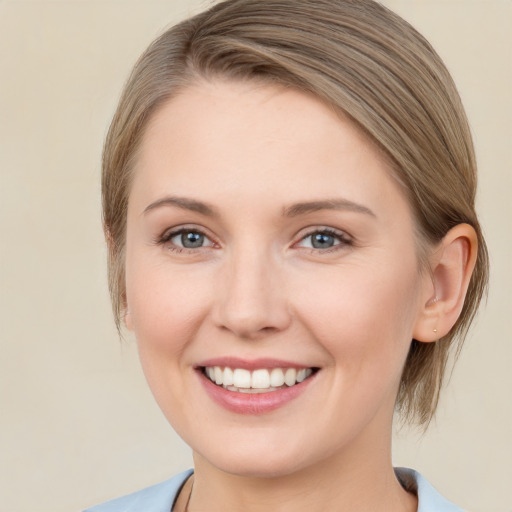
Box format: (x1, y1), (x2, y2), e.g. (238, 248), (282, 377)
(90, 0), (488, 512)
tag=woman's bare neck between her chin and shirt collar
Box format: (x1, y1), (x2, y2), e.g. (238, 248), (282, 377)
(188, 422), (417, 512)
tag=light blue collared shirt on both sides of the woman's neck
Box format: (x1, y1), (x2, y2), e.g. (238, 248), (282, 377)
(84, 468), (464, 512)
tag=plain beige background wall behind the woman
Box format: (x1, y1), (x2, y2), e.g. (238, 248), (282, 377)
(0, 0), (512, 512)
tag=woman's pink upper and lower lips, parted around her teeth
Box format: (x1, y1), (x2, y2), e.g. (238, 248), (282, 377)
(196, 358), (315, 415)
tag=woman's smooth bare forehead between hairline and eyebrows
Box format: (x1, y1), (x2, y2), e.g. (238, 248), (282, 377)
(133, 81), (412, 222)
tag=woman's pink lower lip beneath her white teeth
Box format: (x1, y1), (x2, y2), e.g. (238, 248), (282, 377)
(198, 370), (316, 415)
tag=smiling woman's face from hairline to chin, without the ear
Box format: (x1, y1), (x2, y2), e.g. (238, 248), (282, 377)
(126, 82), (426, 476)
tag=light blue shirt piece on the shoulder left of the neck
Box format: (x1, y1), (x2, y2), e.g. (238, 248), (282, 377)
(84, 470), (192, 512)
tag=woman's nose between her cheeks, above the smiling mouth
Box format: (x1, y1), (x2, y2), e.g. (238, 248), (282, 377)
(214, 247), (291, 339)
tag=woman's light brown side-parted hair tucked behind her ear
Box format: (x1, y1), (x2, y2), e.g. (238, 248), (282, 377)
(102, 0), (488, 425)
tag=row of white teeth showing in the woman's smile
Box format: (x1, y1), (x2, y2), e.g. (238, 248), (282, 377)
(205, 366), (313, 393)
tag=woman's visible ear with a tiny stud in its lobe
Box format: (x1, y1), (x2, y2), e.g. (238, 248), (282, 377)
(413, 224), (478, 342)
